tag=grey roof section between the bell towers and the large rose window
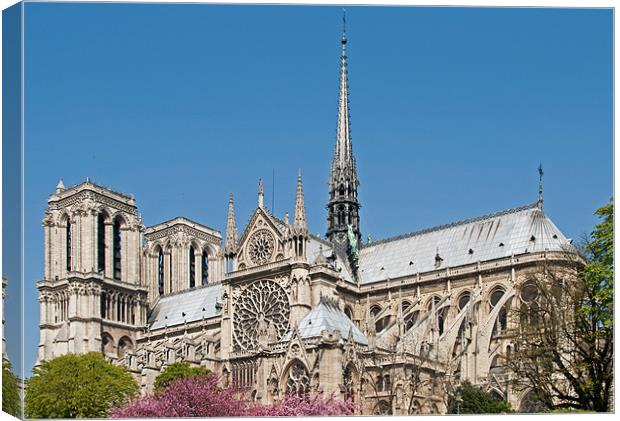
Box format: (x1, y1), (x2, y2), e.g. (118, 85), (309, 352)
(148, 283), (222, 329)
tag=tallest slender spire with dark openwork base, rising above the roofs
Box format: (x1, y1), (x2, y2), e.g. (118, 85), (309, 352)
(327, 10), (361, 249)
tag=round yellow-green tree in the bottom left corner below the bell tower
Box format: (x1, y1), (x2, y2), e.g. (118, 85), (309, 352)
(25, 352), (139, 418)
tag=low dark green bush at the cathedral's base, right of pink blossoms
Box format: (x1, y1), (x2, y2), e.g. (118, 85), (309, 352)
(448, 382), (513, 414)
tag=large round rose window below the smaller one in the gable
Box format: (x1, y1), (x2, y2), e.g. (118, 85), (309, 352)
(233, 280), (290, 350)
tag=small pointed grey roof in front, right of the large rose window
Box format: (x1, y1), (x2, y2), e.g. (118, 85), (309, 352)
(284, 298), (368, 345)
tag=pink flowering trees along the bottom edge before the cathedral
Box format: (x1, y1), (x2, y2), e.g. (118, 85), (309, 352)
(111, 374), (356, 418)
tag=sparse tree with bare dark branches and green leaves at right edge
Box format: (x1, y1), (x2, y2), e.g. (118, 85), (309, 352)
(508, 200), (614, 412)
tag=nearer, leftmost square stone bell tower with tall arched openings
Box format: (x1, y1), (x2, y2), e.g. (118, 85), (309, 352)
(37, 179), (147, 362)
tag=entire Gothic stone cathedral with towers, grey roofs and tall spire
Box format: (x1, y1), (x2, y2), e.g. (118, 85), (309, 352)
(37, 27), (570, 414)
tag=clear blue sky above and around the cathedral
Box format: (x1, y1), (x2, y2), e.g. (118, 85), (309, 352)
(17, 3), (613, 370)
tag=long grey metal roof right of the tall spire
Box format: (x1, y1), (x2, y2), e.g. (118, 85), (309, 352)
(358, 204), (570, 283)
